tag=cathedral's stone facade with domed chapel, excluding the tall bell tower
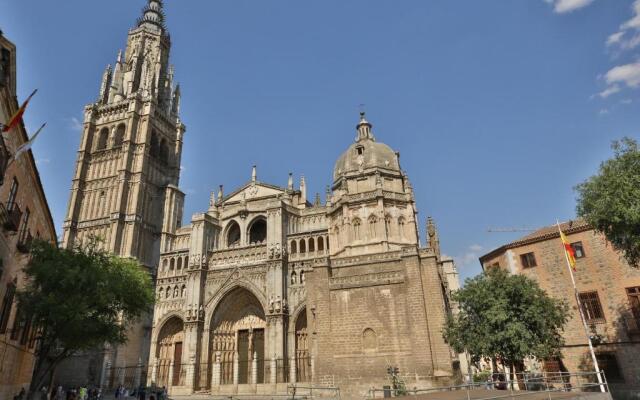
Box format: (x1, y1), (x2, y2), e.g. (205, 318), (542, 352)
(148, 114), (458, 395)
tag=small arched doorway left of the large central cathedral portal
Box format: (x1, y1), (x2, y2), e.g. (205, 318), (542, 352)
(156, 317), (184, 387)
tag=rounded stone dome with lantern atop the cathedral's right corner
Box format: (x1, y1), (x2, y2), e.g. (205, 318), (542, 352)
(333, 113), (400, 181)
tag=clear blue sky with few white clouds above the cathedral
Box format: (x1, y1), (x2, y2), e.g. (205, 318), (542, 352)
(0, 0), (640, 277)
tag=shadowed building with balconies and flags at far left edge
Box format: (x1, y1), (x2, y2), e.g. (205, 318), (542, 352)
(0, 33), (56, 399)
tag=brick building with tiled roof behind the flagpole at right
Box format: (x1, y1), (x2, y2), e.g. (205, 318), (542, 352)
(480, 220), (640, 396)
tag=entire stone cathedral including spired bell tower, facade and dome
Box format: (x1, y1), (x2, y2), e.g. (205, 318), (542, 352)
(62, 0), (460, 395)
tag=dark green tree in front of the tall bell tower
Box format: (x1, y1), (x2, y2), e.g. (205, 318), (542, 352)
(17, 238), (153, 396)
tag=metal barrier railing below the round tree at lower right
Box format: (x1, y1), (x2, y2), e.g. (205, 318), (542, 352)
(367, 371), (609, 400)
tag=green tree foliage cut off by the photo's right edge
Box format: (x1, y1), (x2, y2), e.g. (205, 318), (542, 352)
(576, 138), (640, 268)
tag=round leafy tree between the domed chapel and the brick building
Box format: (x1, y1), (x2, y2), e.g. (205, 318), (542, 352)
(443, 268), (569, 384)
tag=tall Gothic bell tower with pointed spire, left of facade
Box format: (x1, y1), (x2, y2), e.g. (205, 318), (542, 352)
(62, 0), (185, 378)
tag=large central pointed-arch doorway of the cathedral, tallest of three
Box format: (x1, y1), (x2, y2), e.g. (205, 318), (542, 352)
(209, 288), (267, 385)
